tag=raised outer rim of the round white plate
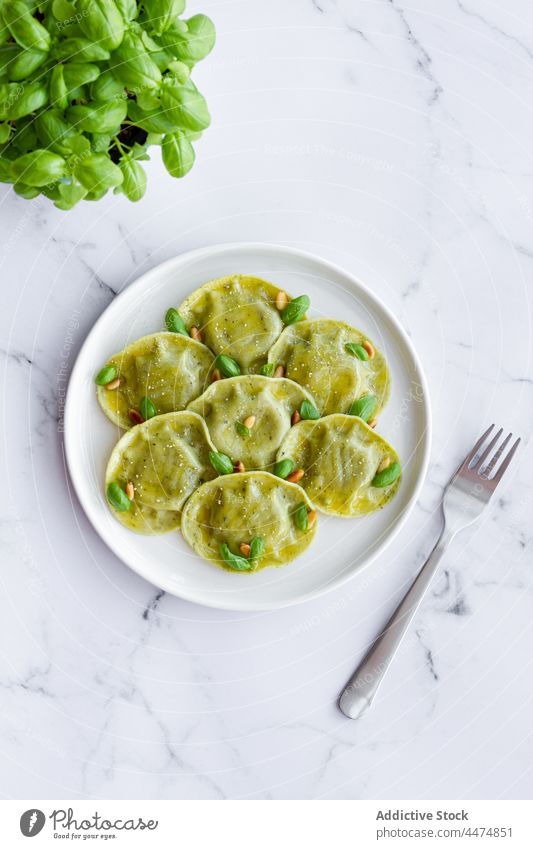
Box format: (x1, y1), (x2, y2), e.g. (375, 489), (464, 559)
(63, 241), (432, 613)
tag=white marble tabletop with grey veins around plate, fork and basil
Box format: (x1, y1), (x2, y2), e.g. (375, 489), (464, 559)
(0, 0), (533, 799)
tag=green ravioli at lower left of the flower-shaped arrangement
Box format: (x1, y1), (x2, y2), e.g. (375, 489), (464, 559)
(106, 411), (216, 534)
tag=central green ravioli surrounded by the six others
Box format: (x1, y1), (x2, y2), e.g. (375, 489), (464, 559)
(188, 375), (314, 469)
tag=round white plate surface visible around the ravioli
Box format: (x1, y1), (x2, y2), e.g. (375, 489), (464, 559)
(65, 243), (431, 610)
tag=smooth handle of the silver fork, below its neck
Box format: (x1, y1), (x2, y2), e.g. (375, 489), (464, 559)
(339, 529), (454, 719)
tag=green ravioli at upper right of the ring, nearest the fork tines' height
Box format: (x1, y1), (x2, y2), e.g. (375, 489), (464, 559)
(268, 318), (390, 415)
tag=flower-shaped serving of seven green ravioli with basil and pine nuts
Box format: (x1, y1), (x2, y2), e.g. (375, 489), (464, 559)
(95, 275), (401, 572)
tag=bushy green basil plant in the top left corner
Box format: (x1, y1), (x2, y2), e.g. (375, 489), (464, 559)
(0, 0), (215, 209)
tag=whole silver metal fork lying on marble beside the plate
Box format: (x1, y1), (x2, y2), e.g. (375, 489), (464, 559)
(339, 424), (520, 719)
